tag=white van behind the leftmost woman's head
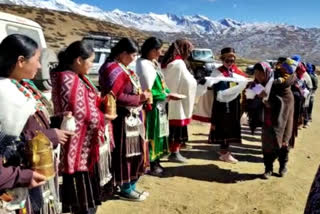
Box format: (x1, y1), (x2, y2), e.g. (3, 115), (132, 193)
(0, 12), (57, 90)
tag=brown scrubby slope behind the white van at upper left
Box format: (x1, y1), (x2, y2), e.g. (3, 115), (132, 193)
(0, 4), (148, 51)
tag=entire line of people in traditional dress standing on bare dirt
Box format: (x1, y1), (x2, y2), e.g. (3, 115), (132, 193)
(0, 34), (316, 213)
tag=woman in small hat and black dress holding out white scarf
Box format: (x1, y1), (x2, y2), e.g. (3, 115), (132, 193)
(210, 47), (245, 163)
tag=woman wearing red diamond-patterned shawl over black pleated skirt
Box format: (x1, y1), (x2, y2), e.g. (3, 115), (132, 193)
(50, 41), (108, 213)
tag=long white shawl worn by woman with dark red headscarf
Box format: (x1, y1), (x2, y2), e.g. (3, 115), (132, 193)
(162, 59), (197, 120)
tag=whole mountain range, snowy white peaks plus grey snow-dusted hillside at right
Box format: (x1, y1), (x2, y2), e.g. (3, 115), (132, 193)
(0, 0), (320, 63)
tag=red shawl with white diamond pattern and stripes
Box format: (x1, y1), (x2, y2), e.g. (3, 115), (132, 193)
(50, 71), (105, 174)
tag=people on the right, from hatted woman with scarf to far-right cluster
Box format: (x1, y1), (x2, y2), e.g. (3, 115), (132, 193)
(193, 48), (318, 179)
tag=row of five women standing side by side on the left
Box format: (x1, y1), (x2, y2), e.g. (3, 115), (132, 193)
(0, 34), (197, 213)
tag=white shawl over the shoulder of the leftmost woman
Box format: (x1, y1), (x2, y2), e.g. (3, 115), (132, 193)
(0, 78), (36, 136)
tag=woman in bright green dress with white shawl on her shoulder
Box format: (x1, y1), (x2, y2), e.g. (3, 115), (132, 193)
(136, 37), (174, 176)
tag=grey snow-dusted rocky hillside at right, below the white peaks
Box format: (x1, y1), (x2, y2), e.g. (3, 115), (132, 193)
(149, 26), (320, 64)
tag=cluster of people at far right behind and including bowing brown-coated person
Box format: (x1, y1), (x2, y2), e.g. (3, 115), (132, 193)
(251, 56), (317, 178)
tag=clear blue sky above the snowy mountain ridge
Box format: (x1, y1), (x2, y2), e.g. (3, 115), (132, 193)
(74, 0), (320, 28)
